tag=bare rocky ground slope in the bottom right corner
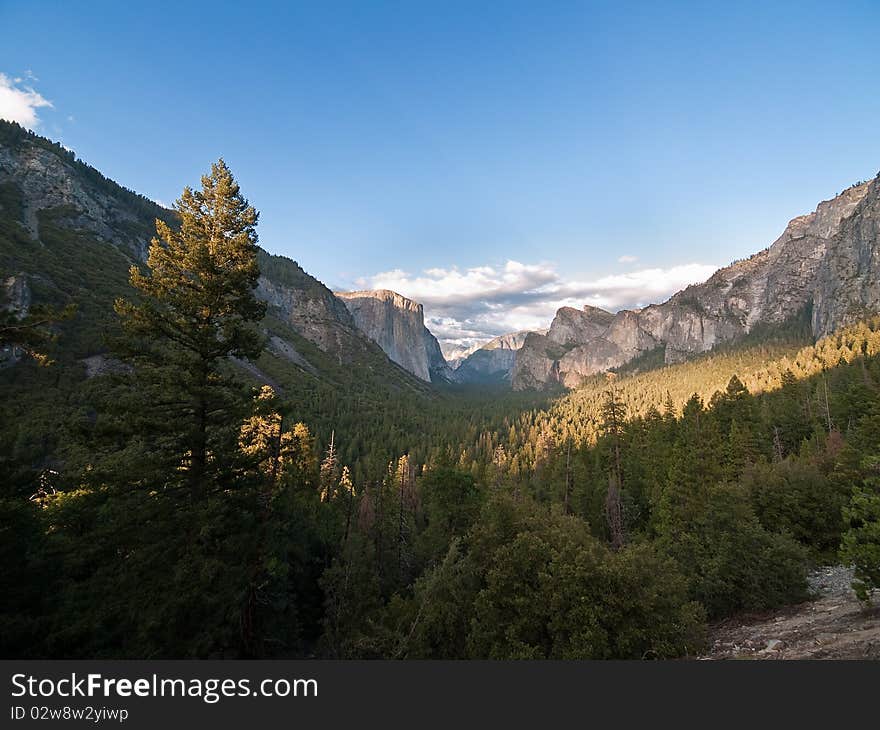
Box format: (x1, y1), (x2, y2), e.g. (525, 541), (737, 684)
(701, 566), (880, 659)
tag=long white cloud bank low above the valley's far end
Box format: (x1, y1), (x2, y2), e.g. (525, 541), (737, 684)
(348, 261), (718, 353)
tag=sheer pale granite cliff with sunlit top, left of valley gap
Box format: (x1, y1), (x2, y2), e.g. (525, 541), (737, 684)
(336, 289), (452, 382)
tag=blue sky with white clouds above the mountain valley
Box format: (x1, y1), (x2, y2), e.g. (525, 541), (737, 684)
(0, 0), (880, 352)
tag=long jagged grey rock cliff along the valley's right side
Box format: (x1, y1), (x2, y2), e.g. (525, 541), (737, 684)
(512, 176), (880, 389)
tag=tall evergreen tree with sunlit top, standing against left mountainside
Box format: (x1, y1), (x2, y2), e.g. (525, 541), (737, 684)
(116, 159), (265, 499)
